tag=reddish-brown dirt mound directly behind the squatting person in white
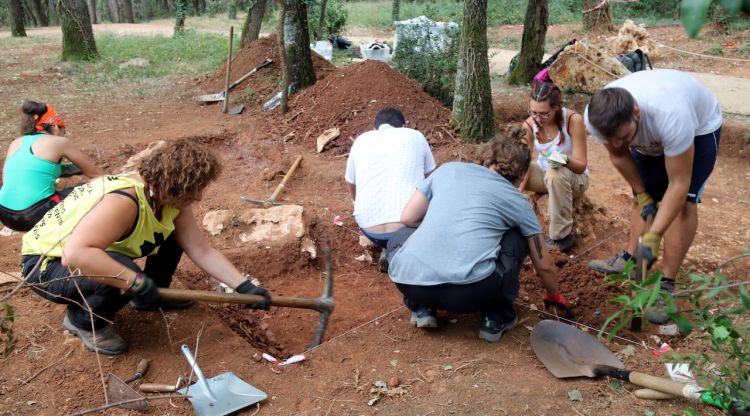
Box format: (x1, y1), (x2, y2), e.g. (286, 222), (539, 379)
(274, 60), (455, 154)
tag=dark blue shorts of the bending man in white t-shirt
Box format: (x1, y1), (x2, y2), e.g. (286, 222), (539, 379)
(630, 127), (721, 204)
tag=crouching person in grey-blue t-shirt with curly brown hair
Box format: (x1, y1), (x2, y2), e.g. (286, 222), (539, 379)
(388, 127), (567, 342)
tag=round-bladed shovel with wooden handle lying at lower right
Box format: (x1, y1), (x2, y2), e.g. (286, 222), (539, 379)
(531, 320), (702, 401)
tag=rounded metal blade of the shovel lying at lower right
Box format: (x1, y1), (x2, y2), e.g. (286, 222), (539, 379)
(531, 320), (623, 378)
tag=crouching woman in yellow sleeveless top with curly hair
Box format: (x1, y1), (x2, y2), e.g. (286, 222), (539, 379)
(22, 140), (270, 355)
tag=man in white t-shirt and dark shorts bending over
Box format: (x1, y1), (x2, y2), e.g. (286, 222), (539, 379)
(584, 69), (722, 323)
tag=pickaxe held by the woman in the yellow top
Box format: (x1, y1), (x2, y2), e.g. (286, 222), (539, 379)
(159, 248), (333, 348)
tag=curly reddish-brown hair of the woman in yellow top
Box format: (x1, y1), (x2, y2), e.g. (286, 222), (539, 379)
(138, 139), (221, 206)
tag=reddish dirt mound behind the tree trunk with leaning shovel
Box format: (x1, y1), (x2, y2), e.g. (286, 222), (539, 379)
(198, 33), (336, 107)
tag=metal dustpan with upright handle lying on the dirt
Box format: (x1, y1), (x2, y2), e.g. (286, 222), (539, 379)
(178, 344), (268, 416)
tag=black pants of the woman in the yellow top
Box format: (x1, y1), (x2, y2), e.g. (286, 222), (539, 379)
(22, 235), (182, 329)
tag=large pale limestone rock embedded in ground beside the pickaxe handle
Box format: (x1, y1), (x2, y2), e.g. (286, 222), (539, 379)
(239, 205), (306, 244)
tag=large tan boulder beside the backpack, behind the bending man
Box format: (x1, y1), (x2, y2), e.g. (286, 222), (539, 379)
(549, 41), (630, 93)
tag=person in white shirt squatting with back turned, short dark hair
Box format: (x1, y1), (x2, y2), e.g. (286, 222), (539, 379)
(344, 107), (435, 272)
